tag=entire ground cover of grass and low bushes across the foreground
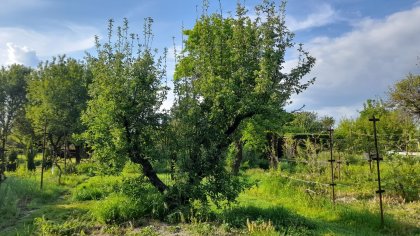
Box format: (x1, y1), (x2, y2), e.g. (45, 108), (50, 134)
(0, 169), (420, 235)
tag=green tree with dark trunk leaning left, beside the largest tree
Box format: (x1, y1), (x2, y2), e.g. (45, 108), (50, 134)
(83, 18), (168, 193)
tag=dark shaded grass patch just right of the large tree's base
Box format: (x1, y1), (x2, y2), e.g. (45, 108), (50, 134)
(221, 206), (316, 234)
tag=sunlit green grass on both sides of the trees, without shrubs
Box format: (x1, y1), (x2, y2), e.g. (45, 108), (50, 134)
(0, 160), (420, 235)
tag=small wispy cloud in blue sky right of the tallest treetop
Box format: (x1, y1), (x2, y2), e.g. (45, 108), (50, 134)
(286, 4), (337, 31)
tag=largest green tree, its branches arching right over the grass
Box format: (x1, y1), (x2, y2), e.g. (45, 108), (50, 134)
(173, 1), (315, 205)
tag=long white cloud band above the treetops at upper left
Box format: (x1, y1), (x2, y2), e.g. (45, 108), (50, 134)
(0, 24), (99, 65)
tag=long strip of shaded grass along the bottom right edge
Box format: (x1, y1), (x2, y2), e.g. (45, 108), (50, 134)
(220, 205), (420, 235)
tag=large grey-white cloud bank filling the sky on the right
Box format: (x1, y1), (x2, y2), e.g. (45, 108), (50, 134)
(290, 7), (420, 119)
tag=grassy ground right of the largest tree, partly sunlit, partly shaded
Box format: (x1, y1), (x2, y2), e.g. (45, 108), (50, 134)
(228, 170), (420, 235)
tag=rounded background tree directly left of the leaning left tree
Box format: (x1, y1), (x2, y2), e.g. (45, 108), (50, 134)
(26, 56), (91, 176)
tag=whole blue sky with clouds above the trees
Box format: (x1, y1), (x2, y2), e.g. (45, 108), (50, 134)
(0, 0), (420, 120)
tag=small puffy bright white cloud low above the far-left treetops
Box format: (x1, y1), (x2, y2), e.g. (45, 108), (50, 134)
(6, 43), (39, 67)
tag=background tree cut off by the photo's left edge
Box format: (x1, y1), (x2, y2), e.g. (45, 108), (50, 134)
(0, 65), (31, 177)
